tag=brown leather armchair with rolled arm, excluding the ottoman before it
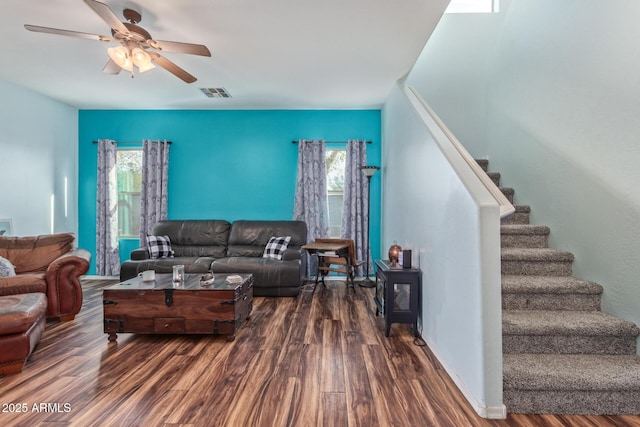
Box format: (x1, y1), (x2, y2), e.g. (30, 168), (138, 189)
(0, 233), (91, 321)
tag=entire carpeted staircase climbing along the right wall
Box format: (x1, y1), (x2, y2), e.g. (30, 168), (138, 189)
(478, 160), (640, 414)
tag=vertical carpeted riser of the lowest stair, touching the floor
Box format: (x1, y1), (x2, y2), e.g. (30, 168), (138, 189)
(504, 389), (640, 415)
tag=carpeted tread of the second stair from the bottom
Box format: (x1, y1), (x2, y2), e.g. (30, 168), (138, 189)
(502, 310), (640, 336)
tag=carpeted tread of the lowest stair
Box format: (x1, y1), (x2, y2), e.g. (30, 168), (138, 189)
(503, 354), (640, 390)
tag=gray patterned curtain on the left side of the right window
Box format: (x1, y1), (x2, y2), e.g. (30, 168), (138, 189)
(293, 139), (329, 277)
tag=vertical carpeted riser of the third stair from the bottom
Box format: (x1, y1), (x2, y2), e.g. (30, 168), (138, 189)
(502, 292), (601, 311)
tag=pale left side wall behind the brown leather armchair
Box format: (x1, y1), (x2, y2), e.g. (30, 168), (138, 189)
(0, 81), (78, 236)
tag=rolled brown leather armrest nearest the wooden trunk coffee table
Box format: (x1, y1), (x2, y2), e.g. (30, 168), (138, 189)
(45, 249), (91, 321)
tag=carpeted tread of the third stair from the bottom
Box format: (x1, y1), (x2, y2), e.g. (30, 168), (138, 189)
(502, 274), (603, 295)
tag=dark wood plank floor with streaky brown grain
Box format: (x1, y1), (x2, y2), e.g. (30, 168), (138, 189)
(0, 280), (640, 427)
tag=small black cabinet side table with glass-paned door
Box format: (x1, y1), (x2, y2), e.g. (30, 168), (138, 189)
(374, 260), (422, 337)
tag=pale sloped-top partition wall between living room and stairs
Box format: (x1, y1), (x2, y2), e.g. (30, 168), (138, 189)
(381, 85), (504, 418)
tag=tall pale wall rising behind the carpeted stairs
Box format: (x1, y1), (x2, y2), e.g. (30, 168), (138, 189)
(409, 0), (640, 352)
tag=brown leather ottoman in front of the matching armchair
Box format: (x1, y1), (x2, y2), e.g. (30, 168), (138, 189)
(0, 293), (47, 374)
